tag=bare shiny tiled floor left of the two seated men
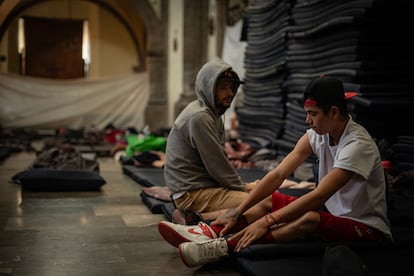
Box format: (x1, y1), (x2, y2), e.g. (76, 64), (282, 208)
(0, 146), (240, 276)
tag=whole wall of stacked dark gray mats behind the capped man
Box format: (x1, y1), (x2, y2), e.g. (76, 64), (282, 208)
(237, 0), (414, 161)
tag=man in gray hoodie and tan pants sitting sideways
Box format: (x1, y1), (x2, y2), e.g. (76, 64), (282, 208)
(164, 58), (254, 224)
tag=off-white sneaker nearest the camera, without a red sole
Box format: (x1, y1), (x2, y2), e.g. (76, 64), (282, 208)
(179, 238), (228, 267)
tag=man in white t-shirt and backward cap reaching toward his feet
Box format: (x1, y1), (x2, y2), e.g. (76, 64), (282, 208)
(158, 76), (392, 266)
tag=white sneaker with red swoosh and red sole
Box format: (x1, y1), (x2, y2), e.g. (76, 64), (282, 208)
(158, 221), (217, 247)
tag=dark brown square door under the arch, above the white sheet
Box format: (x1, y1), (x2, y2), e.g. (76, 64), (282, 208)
(22, 17), (85, 79)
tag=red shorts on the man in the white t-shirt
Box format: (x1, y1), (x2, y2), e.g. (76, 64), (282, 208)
(272, 192), (383, 241)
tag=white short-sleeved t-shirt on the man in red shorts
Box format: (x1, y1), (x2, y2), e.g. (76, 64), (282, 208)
(307, 117), (392, 239)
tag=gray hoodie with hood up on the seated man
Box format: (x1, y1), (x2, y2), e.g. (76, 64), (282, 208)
(164, 58), (245, 193)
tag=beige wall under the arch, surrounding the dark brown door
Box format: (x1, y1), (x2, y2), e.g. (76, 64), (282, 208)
(0, 0), (138, 78)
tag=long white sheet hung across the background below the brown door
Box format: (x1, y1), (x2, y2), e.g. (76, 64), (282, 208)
(0, 73), (150, 129)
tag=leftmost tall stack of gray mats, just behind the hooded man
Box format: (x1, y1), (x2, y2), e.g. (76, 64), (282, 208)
(238, 1), (290, 151)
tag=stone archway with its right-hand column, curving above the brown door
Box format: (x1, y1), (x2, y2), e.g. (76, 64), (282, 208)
(0, 0), (168, 129)
